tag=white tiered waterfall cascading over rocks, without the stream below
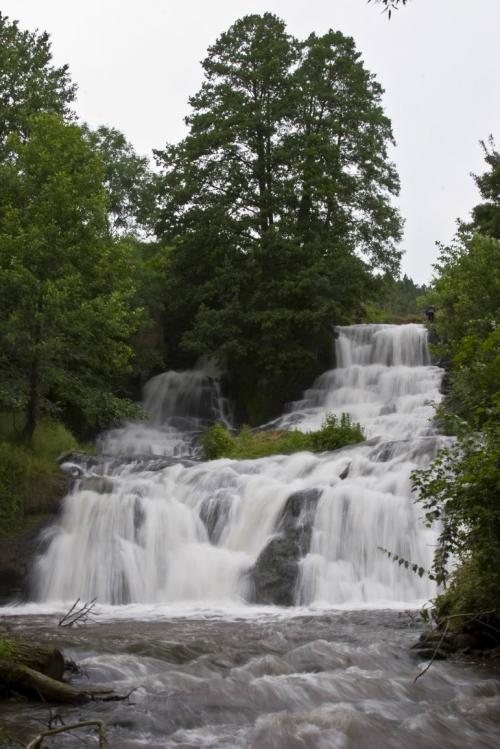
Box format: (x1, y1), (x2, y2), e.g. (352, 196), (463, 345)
(35, 325), (442, 606)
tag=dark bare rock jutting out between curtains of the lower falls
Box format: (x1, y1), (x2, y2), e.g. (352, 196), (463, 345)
(248, 489), (321, 606)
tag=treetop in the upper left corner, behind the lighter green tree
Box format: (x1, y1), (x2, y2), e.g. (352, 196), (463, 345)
(0, 12), (76, 152)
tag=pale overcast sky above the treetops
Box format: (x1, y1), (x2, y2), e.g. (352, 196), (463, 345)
(0, 0), (500, 283)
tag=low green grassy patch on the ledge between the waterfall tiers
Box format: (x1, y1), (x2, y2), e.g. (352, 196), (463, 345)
(203, 414), (365, 460)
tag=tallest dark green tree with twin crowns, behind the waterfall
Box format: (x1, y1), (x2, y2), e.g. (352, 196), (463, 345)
(156, 13), (400, 420)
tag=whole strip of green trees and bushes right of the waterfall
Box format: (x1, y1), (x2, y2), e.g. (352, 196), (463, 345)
(414, 140), (500, 647)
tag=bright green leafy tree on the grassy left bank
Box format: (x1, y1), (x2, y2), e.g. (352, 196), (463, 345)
(0, 114), (144, 437)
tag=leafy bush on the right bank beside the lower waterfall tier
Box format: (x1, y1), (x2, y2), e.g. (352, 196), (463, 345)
(412, 420), (500, 641)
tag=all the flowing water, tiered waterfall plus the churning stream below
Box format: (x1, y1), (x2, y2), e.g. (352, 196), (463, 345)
(0, 325), (500, 749)
